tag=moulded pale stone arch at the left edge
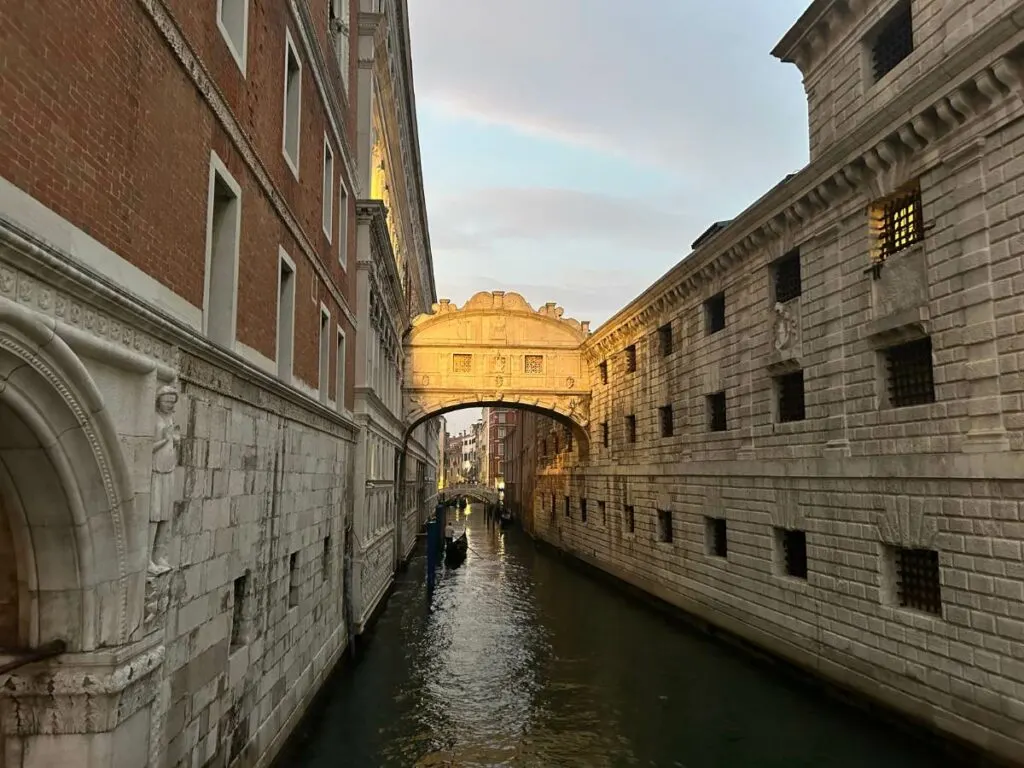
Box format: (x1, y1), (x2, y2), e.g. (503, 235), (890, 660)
(0, 301), (146, 651)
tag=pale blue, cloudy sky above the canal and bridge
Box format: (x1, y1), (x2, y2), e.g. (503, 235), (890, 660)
(409, 0), (810, 433)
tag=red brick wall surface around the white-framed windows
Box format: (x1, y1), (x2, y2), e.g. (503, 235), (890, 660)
(0, 0), (356, 406)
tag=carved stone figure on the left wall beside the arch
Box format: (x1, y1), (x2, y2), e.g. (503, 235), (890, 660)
(148, 385), (181, 574)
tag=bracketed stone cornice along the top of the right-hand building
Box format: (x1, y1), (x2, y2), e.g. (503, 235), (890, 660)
(586, 16), (1024, 360)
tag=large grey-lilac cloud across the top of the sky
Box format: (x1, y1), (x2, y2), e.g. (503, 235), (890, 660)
(411, 0), (806, 191)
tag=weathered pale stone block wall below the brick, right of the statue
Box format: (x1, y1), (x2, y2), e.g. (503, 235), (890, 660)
(157, 362), (351, 766)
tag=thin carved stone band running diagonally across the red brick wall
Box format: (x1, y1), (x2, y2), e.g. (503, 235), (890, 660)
(136, 0), (357, 328)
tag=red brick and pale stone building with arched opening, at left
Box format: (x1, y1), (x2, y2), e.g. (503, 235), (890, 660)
(0, 0), (436, 768)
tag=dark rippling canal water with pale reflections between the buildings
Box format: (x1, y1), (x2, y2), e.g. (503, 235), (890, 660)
(279, 507), (966, 768)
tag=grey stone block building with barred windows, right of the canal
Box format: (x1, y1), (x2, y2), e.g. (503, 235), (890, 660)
(509, 0), (1024, 760)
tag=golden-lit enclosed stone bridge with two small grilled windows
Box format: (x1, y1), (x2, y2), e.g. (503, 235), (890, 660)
(404, 291), (590, 427)
